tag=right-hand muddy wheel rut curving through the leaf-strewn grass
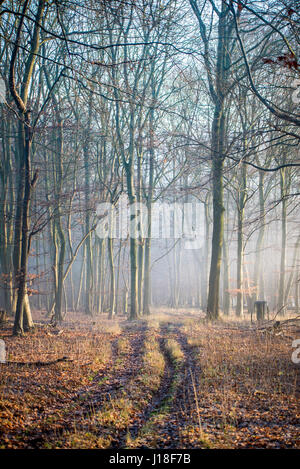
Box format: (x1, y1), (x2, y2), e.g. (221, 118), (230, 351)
(121, 324), (202, 449)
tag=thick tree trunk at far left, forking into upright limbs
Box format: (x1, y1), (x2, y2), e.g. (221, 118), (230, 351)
(9, 0), (45, 335)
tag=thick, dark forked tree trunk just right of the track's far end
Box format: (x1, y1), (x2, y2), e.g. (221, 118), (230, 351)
(190, 0), (234, 320)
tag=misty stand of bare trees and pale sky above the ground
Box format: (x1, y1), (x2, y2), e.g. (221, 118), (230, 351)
(0, 0), (299, 333)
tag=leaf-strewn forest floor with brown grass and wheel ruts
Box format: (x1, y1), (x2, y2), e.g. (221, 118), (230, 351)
(0, 311), (300, 449)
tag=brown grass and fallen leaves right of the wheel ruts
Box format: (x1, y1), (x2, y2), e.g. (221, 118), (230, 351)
(186, 324), (300, 448)
